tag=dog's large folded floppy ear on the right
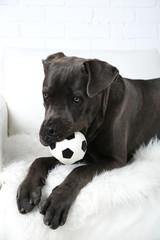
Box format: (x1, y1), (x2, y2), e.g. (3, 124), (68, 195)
(84, 59), (119, 98)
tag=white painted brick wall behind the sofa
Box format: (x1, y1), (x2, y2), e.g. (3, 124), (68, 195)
(0, 0), (160, 94)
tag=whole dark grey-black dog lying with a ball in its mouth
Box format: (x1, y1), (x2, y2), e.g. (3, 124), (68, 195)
(17, 53), (160, 229)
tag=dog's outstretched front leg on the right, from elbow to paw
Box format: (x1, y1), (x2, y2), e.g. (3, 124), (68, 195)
(41, 159), (123, 229)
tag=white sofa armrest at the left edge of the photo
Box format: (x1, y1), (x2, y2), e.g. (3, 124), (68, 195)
(0, 96), (8, 170)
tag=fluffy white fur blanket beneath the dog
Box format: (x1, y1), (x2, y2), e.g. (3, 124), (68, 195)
(0, 134), (160, 240)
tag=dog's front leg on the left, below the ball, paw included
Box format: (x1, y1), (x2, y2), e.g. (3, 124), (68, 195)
(17, 157), (59, 213)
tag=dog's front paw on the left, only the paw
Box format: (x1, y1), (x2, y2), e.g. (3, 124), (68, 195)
(17, 178), (42, 214)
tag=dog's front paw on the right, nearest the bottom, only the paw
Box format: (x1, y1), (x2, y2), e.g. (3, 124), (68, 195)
(41, 186), (73, 229)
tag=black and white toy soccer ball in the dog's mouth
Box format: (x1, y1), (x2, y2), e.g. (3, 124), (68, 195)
(50, 132), (87, 164)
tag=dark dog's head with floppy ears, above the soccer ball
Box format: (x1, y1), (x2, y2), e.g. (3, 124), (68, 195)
(40, 53), (118, 146)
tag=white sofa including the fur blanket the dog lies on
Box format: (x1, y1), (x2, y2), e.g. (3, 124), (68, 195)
(0, 48), (160, 240)
